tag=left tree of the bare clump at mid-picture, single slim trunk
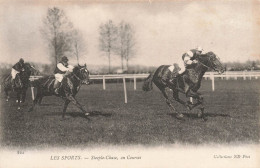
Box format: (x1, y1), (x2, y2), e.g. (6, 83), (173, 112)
(99, 20), (117, 73)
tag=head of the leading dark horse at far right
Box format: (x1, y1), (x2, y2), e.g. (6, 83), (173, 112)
(198, 51), (225, 74)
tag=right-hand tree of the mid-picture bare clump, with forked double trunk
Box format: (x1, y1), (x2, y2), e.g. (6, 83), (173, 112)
(117, 22), (135, 70)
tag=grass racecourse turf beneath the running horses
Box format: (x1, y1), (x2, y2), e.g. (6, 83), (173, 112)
(1, 80), (260, 148)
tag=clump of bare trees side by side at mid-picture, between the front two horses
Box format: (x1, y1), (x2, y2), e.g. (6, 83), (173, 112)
(99, 20), (135, 73)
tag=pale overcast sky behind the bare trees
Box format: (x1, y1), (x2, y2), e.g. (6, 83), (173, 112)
(0, 1), (260, 66)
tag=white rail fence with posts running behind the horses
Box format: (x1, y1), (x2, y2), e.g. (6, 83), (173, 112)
(27, 71), (260, 103)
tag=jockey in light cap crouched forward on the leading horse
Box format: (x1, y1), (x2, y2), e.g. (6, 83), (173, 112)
(177, 46), (204, 76)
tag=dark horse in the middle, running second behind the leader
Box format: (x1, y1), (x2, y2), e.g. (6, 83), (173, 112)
(29, 64), (89, 118)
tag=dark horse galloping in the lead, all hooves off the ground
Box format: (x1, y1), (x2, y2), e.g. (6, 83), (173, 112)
(143, 52), (224, 120)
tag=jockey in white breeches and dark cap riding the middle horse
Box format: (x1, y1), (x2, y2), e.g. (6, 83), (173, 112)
(53, 56), (73, 94)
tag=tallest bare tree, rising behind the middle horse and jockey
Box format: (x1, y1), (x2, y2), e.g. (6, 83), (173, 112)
(41, 7), (73, 64)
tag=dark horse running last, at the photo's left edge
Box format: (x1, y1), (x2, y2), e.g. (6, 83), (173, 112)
(2, 63), (35, 110)
